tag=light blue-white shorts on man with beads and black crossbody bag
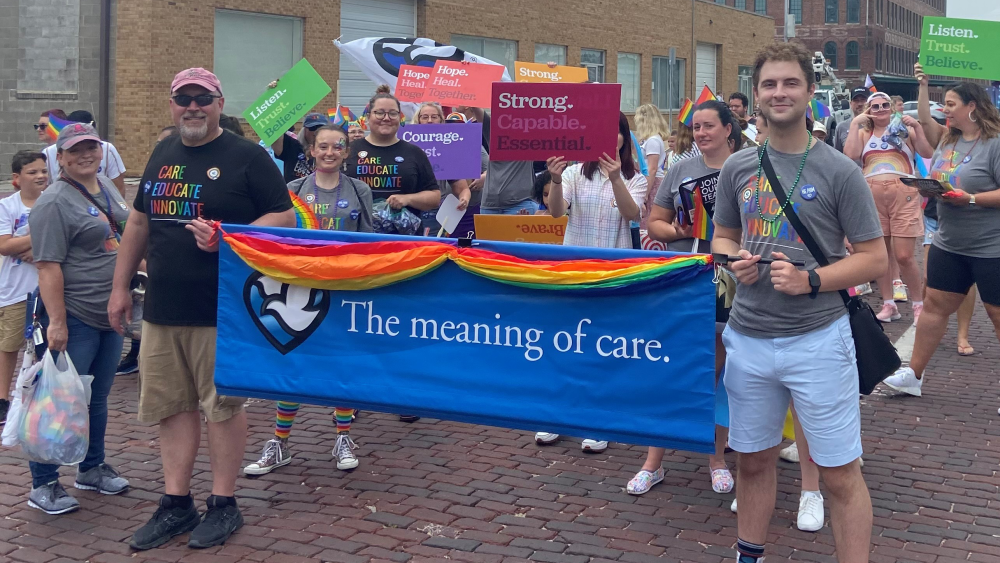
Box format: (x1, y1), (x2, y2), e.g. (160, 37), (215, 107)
(722, 313), (861, 467)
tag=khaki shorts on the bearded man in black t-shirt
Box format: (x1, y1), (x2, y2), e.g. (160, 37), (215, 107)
(139, 321), (246, 422)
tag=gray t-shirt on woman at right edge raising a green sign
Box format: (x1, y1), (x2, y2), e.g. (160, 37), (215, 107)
(928, 137), (1000, 258)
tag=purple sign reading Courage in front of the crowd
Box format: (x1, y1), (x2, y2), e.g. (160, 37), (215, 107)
(398, 123), (483, 180)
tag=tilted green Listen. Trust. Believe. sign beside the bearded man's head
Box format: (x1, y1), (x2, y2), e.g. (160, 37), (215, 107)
(243, 59), (330, 145)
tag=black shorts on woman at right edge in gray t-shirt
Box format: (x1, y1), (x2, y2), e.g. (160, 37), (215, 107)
(927, 244), (1000, 307)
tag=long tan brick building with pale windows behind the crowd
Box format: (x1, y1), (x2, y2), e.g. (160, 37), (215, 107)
(0, 0), (774, 175)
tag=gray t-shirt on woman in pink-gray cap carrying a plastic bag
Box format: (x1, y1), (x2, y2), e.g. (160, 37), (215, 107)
(28, 176), (129, 330)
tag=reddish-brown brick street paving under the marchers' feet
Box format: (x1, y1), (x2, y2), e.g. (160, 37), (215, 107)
(0, 266), (1000, 563)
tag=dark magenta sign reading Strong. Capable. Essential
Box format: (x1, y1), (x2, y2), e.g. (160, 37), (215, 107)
(490, 82), (629, 161)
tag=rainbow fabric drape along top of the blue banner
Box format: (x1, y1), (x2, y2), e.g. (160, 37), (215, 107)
(223, 233), (712, 294)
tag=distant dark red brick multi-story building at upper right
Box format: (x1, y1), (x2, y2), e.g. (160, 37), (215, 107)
(717, 0), (953, 100)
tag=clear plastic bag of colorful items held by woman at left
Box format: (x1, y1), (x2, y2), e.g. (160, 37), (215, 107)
(18, 351), (90, 465)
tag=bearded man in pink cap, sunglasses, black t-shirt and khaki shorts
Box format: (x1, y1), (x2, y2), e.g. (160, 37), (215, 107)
(108, 68), (295, 549)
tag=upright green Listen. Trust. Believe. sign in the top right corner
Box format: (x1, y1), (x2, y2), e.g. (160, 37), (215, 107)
(920, 18), (1000, 80)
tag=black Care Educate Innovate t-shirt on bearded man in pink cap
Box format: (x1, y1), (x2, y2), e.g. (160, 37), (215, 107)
(133, 131), (292, 326)
